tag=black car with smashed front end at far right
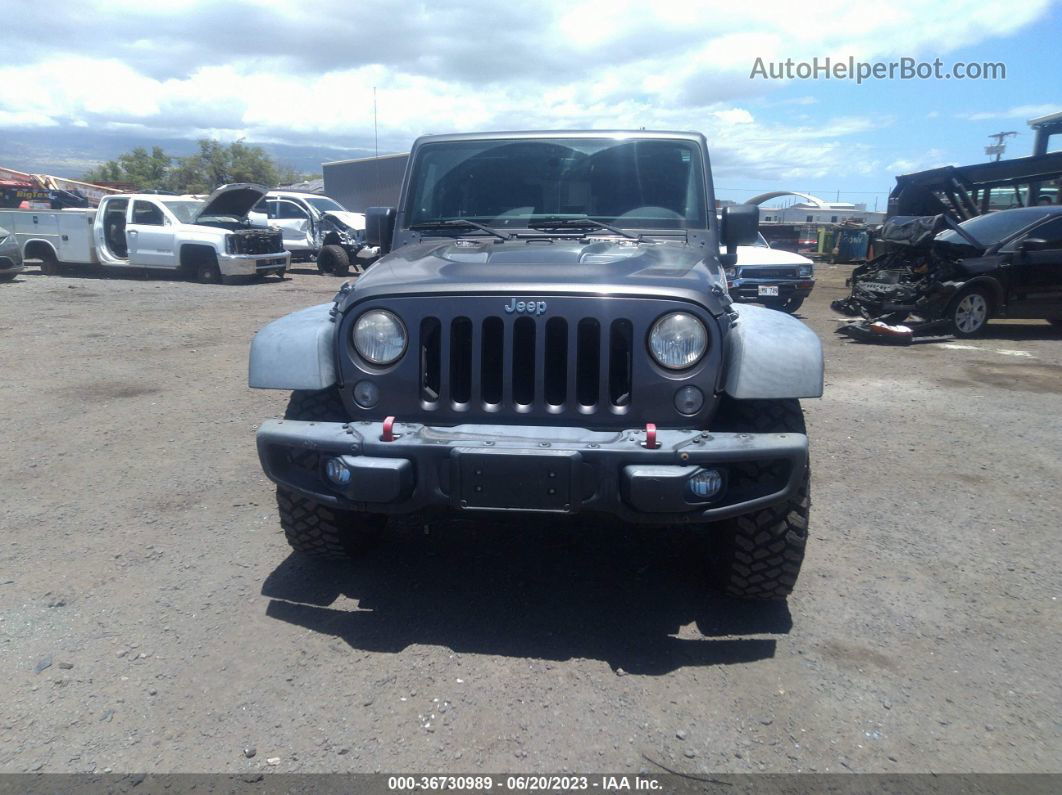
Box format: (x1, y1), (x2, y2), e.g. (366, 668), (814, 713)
(833, 205), (1062, 336)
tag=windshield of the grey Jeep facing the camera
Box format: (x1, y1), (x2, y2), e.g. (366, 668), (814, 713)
(405, 138), (707, 229)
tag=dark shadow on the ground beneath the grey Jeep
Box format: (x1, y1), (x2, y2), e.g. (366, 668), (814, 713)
(261, 517), (792, 675)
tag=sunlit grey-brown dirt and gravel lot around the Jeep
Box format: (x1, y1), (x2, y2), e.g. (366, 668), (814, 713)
(0, 263), (1062, 772)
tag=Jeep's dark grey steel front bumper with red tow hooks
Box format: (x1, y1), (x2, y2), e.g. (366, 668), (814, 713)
(258, 419), (807, 523)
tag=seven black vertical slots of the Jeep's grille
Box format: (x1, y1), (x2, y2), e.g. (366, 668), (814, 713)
(416, 315), (634, 414)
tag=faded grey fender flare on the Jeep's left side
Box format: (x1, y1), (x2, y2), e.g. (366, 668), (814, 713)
(247, 304), (336, 391)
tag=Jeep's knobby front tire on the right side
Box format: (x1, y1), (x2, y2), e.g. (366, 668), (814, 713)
(705, 398), (811, 600)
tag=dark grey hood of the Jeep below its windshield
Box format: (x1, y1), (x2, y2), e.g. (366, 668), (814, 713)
(343, 238), (730, 314)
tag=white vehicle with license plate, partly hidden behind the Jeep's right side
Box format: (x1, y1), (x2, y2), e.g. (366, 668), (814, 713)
(726, 232), (815, 314)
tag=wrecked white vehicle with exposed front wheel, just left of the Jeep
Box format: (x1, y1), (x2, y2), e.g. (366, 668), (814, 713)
(251, 190), (379, 276)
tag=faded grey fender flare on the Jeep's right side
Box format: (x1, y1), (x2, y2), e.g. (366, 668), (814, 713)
(723, 304), (824, 400)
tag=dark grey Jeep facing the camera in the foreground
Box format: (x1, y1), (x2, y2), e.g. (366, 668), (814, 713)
(249, 131), (823, 599)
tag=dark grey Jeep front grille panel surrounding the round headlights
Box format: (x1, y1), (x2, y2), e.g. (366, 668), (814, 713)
(341, 293), (722, 428)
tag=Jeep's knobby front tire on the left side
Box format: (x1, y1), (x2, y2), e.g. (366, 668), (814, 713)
(276, 387), (387, 559)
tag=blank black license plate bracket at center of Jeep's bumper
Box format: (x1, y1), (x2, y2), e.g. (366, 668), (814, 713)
(451, 448), (578, 513)
